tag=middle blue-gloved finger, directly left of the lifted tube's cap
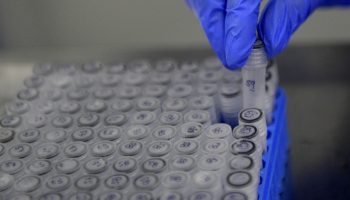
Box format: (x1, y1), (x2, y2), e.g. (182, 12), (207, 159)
(225, 0), (261, 69)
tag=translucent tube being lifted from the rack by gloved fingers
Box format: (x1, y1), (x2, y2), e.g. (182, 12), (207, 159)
(242, 40), (268, 109)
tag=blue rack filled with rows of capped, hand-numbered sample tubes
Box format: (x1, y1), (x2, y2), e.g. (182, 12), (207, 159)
(0, 48), (287, 200)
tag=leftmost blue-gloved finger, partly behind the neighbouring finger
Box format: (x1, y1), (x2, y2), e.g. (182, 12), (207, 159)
(187, 0), (226, 65)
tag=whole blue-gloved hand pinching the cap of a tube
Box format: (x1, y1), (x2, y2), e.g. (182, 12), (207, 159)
(187, 0), (350, 69)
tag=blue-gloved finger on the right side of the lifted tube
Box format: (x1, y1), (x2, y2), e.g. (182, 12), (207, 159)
(258, 0), (320, 58)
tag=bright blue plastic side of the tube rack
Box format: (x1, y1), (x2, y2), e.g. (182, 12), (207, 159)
(258, 88), (292, 200)
